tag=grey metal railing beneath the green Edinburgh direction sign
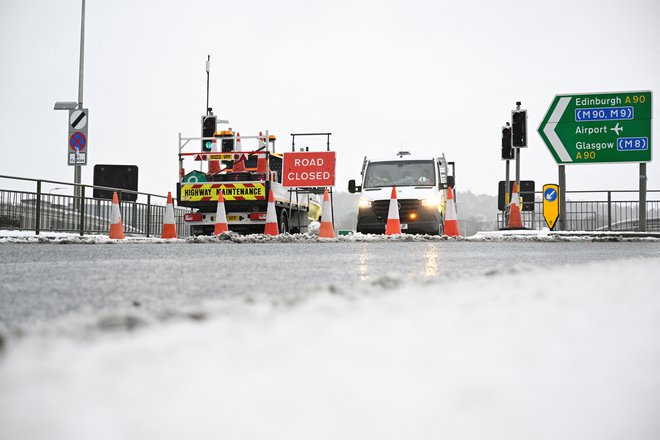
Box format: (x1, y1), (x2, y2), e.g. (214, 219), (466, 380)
(497, 190), (660, 232)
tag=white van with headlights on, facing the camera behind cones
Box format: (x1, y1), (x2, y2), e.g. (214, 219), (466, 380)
(348, 151), (455, 235)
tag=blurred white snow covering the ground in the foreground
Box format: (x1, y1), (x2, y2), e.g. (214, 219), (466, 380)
(0, 258), (660, 440)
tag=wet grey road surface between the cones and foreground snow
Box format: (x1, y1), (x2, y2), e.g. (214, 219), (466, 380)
(0, 241), (660, 329)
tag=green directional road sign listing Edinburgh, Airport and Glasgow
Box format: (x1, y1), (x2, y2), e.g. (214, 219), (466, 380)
(538, 91), (652, 164)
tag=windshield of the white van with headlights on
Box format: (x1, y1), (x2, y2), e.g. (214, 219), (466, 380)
(364, 160), (435, 188)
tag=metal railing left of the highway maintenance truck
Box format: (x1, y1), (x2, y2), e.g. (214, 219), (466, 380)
(0, 175), (190, 237)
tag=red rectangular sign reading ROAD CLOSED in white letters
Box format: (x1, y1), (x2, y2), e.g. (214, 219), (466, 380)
(282, 151), (335, 188)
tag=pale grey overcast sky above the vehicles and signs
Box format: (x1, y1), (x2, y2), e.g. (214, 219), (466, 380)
(0, 0), (660, 194)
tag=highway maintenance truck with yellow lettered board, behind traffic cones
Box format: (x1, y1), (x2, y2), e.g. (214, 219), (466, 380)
(177, 114), (321, 235)
